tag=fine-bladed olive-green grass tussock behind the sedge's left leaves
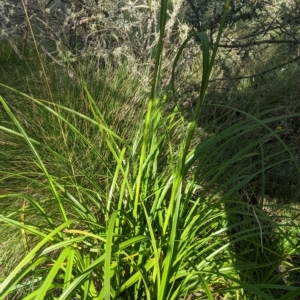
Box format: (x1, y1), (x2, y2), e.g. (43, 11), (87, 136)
(0, 40), (146, 286)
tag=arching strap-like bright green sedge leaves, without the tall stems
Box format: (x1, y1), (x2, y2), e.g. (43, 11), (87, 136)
(1, 92), (295, 299)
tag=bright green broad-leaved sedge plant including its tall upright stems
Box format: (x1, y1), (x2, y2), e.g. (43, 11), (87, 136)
(0, 0), (300, 300)
